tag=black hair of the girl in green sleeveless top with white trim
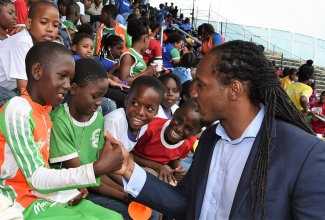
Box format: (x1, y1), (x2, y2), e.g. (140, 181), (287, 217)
(127, 19), (148, 43)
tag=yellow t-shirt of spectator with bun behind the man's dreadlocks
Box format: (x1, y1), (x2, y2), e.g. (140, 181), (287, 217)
(286, 82), (313, 111)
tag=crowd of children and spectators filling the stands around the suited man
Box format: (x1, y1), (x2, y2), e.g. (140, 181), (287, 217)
(0, 0), (325, 219)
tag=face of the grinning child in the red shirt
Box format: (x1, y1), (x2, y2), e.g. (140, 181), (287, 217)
(164, 106), (201, 144)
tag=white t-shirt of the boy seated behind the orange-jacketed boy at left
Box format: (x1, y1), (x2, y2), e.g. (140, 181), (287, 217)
(0, 29), (34, 90)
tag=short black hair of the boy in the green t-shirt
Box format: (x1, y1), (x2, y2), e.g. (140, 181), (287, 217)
(71, 58), (107, 87)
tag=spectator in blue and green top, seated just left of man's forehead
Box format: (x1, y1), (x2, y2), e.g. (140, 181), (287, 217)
(162, 34), (184, 69)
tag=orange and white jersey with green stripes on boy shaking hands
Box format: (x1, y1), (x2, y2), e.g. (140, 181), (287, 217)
(0, 91), (99, 211)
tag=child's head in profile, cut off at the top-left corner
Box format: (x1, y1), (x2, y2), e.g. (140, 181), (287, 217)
(0, 0), (17, 42)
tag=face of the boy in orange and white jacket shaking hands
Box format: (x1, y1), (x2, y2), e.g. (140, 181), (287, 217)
(34, 55), (75, 107)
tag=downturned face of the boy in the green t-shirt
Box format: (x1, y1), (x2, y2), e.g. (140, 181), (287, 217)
(70, 79), (108, 119)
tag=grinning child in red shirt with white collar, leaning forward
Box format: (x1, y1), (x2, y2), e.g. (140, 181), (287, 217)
(132, 100), (202, 185)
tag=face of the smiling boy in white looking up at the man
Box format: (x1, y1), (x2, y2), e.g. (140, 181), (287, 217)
(124, 86), (161, 137)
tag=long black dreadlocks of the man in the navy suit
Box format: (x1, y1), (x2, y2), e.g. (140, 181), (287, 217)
(209, 40), (314, 219)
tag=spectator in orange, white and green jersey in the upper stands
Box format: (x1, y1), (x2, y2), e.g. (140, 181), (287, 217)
(94, 5), (131, 56)
